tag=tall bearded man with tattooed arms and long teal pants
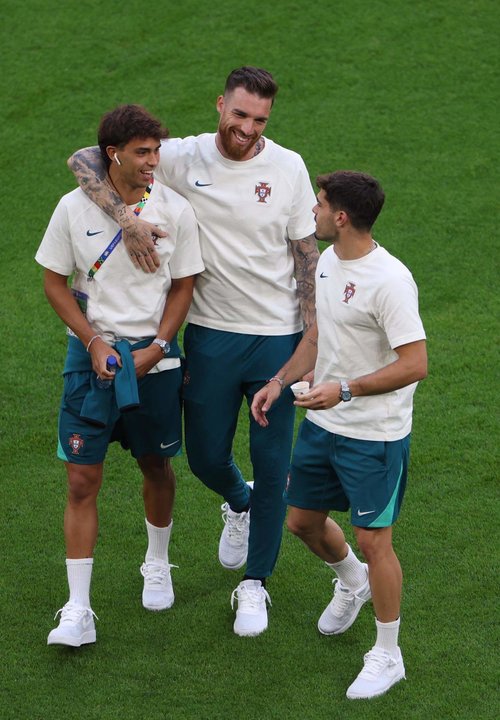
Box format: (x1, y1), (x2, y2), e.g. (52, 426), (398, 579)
(70, 67), (319, 635)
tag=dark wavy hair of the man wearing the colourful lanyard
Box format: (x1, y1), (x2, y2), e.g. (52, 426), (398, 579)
(97, 105), (169, 166)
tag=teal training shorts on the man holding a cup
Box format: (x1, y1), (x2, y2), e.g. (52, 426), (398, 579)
(284, 419), (410, 528)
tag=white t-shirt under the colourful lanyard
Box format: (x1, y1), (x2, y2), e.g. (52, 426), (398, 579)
(35, 182), (204, 370)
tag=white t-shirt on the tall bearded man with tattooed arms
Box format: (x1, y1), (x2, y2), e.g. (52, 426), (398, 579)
(155, 134), (316, 335)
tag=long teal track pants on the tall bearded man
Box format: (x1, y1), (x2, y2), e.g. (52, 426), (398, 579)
(184, 324), (301, 578)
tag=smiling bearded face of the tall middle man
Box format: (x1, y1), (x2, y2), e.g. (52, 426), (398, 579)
(216, 87), (272, 160)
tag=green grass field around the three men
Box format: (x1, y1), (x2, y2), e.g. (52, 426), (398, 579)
(0, 0), (500, 720)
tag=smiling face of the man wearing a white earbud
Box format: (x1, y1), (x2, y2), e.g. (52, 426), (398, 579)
(107, 138), (160, 196)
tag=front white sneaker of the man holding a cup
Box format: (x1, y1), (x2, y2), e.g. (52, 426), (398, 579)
(346, 647), (406, 700)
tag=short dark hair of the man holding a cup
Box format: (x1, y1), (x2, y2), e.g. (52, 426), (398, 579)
(316, 170), (385, 230)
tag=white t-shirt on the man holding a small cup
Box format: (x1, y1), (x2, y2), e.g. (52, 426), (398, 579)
(307, 245), (425, 441)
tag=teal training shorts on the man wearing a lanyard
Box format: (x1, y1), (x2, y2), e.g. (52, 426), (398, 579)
(57, 368), (182, 465)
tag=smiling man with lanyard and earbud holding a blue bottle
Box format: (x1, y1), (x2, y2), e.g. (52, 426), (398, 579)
(36, 105), (203, 647)
